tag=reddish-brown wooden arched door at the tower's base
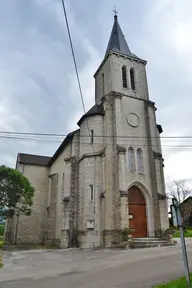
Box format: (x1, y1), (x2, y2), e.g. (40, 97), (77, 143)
(128, 186), (147, 238)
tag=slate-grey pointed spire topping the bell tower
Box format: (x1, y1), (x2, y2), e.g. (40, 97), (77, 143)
(105, 15), (138, 58)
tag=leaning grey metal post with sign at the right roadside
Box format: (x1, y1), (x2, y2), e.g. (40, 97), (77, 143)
(171, 198), (191, 288)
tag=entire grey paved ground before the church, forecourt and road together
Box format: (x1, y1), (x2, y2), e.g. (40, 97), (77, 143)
(0, 244), (192, 288)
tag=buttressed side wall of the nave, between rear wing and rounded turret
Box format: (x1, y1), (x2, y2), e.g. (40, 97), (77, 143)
(50, 131), (80, 248)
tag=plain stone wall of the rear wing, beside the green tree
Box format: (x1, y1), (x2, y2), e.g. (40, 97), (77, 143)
(5, 164), (48, 244)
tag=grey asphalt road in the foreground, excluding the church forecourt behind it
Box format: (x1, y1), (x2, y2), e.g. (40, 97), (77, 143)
(0, 250), (192, 288)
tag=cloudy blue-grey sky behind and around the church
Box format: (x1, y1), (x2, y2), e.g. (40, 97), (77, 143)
(0, 0), (192, 181)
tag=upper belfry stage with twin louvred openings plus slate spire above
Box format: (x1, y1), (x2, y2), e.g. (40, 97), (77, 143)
(94, 11), (149, 104)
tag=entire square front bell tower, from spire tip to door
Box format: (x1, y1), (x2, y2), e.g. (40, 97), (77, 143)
(94, 13), (168, 241)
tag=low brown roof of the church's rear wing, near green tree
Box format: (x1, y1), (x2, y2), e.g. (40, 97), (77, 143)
(17, 153), (51, 166)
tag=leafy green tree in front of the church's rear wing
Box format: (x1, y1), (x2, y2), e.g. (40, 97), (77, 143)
(0, 166), (35, 217)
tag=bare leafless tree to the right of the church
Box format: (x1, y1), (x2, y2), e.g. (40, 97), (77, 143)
(168, 180), (192, 204)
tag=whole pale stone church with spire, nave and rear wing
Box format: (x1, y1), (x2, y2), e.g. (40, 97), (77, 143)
(5, 15), (168, 248)
